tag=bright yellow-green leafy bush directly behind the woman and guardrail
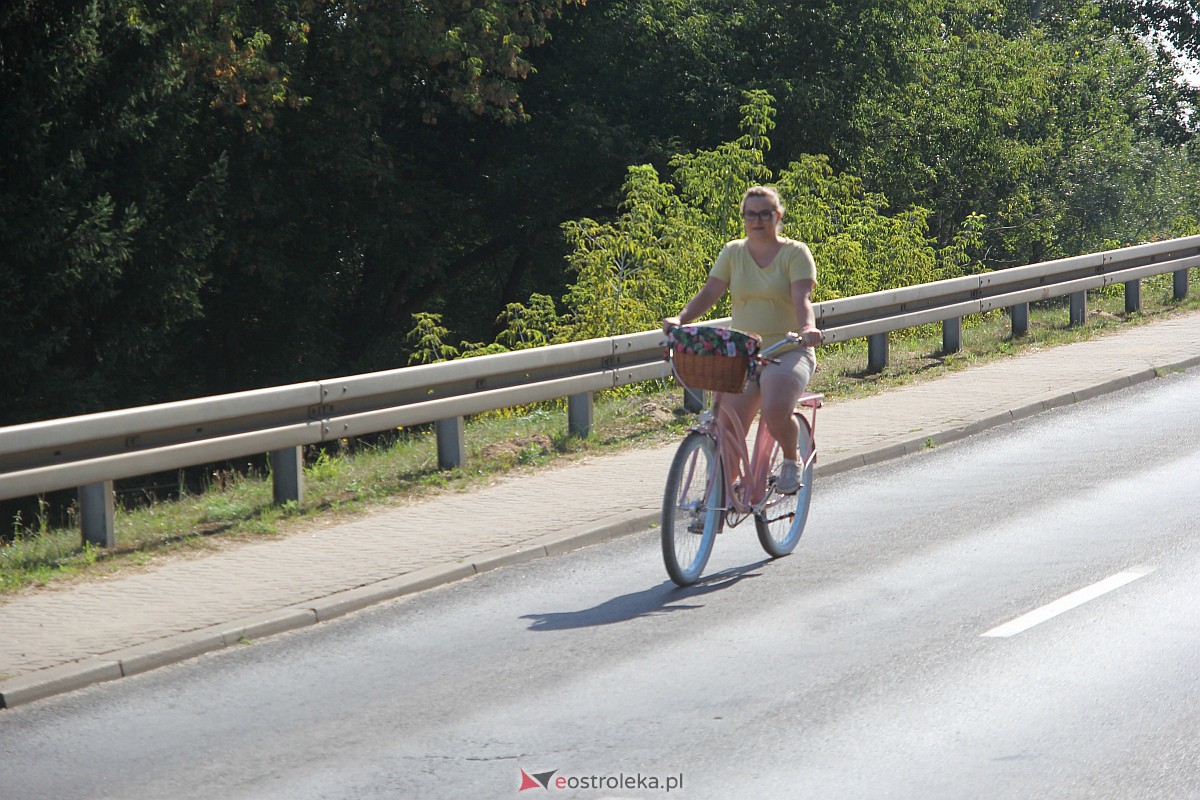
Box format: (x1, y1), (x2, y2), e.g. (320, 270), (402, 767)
(564, 91), (980, 338)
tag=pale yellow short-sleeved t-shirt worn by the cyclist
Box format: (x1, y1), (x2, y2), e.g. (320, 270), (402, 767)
(708, 239), (817, 347)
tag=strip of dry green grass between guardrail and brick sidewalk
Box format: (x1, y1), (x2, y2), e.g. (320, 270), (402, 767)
(0, 275), (1200, 596)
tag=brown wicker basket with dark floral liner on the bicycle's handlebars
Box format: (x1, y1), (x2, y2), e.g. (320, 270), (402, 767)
(667, 325), (761, 395)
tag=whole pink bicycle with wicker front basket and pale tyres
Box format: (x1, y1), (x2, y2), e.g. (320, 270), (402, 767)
(661, 325), (823, 587)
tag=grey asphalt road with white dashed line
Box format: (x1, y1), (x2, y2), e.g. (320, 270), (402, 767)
(0, 372), (1200, 800)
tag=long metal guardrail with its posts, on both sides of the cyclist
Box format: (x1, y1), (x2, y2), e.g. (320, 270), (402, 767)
(7, 236), (1200, 545)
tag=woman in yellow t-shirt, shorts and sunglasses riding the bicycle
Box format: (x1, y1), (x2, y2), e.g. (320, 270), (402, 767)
(662, 186), (821, 494)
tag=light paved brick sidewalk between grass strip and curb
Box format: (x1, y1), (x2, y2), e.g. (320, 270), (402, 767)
(0, 314), (1200, 708)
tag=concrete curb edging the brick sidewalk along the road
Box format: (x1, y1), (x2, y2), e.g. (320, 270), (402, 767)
(0, 356), (1200, 709)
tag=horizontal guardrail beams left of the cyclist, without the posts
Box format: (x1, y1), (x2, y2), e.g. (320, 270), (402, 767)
(0, 335), (656, 499)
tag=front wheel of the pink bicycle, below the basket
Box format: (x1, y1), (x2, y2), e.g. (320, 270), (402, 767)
(661, 432), (725, 587)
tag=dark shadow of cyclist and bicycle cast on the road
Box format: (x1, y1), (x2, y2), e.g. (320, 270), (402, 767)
(521, 559), (770, 631)
